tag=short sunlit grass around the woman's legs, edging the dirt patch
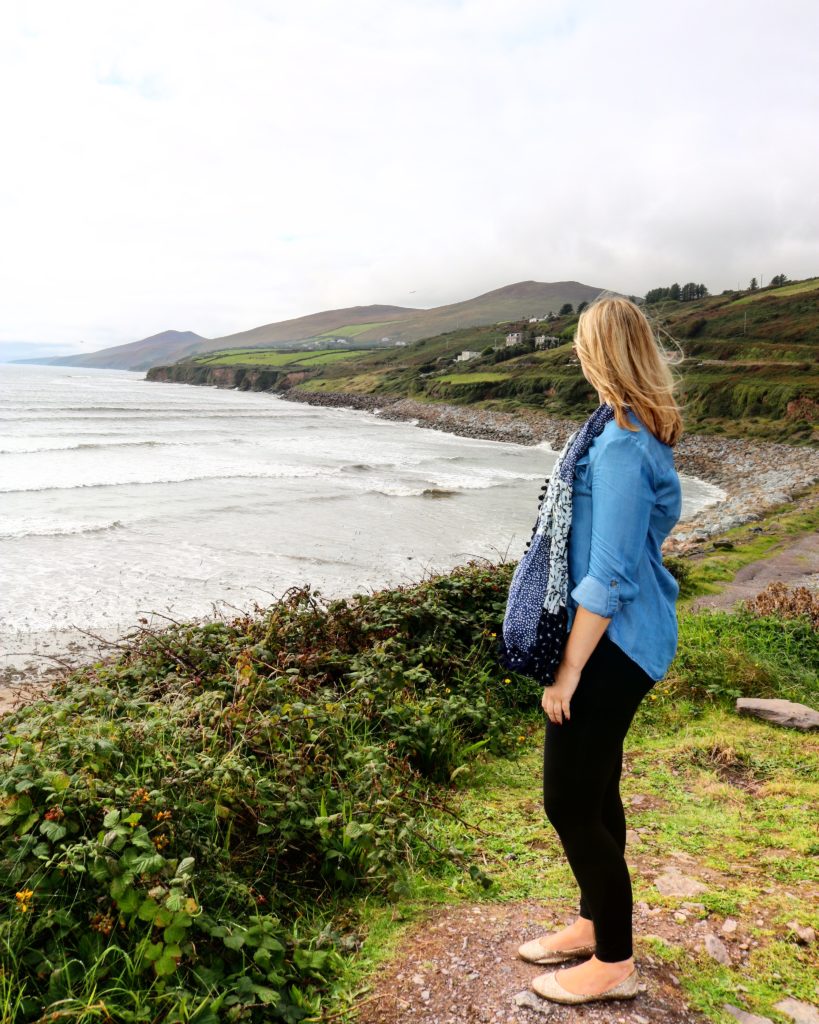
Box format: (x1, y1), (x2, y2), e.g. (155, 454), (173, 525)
(319, 690), (819, 1021)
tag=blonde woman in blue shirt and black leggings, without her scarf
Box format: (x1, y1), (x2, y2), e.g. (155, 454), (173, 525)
(519, 297), (683, 1002)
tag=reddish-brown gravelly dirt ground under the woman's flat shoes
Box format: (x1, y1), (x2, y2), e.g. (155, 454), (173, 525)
(348, 839), (819, 1024)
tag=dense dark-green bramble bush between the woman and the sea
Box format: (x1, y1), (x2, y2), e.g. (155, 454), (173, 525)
(0, 562), (541, 1024)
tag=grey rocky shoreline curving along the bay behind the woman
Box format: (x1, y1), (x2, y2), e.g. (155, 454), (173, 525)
(279, 389), (819, 554)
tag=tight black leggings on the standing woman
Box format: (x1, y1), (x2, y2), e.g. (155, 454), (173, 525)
(544, 633), (655, 963)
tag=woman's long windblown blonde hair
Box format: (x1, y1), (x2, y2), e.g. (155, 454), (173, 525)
(574, 294), (685, 445)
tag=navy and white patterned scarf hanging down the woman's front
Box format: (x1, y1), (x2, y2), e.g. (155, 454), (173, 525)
(498, 402), (614, 686)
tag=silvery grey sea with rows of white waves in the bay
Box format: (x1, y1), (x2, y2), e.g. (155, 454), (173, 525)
(0, 364), (722, 684)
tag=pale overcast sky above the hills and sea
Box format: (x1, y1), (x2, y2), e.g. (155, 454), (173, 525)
(0, 0), (819, 354)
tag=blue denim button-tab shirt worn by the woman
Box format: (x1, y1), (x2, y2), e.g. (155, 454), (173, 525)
(566, 409), (682, 681)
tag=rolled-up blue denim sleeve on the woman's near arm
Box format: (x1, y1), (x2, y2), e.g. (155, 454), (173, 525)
(571, 436), (654, 618)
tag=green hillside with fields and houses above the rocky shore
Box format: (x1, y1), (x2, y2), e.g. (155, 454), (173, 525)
(187, 279), (819, 443)
